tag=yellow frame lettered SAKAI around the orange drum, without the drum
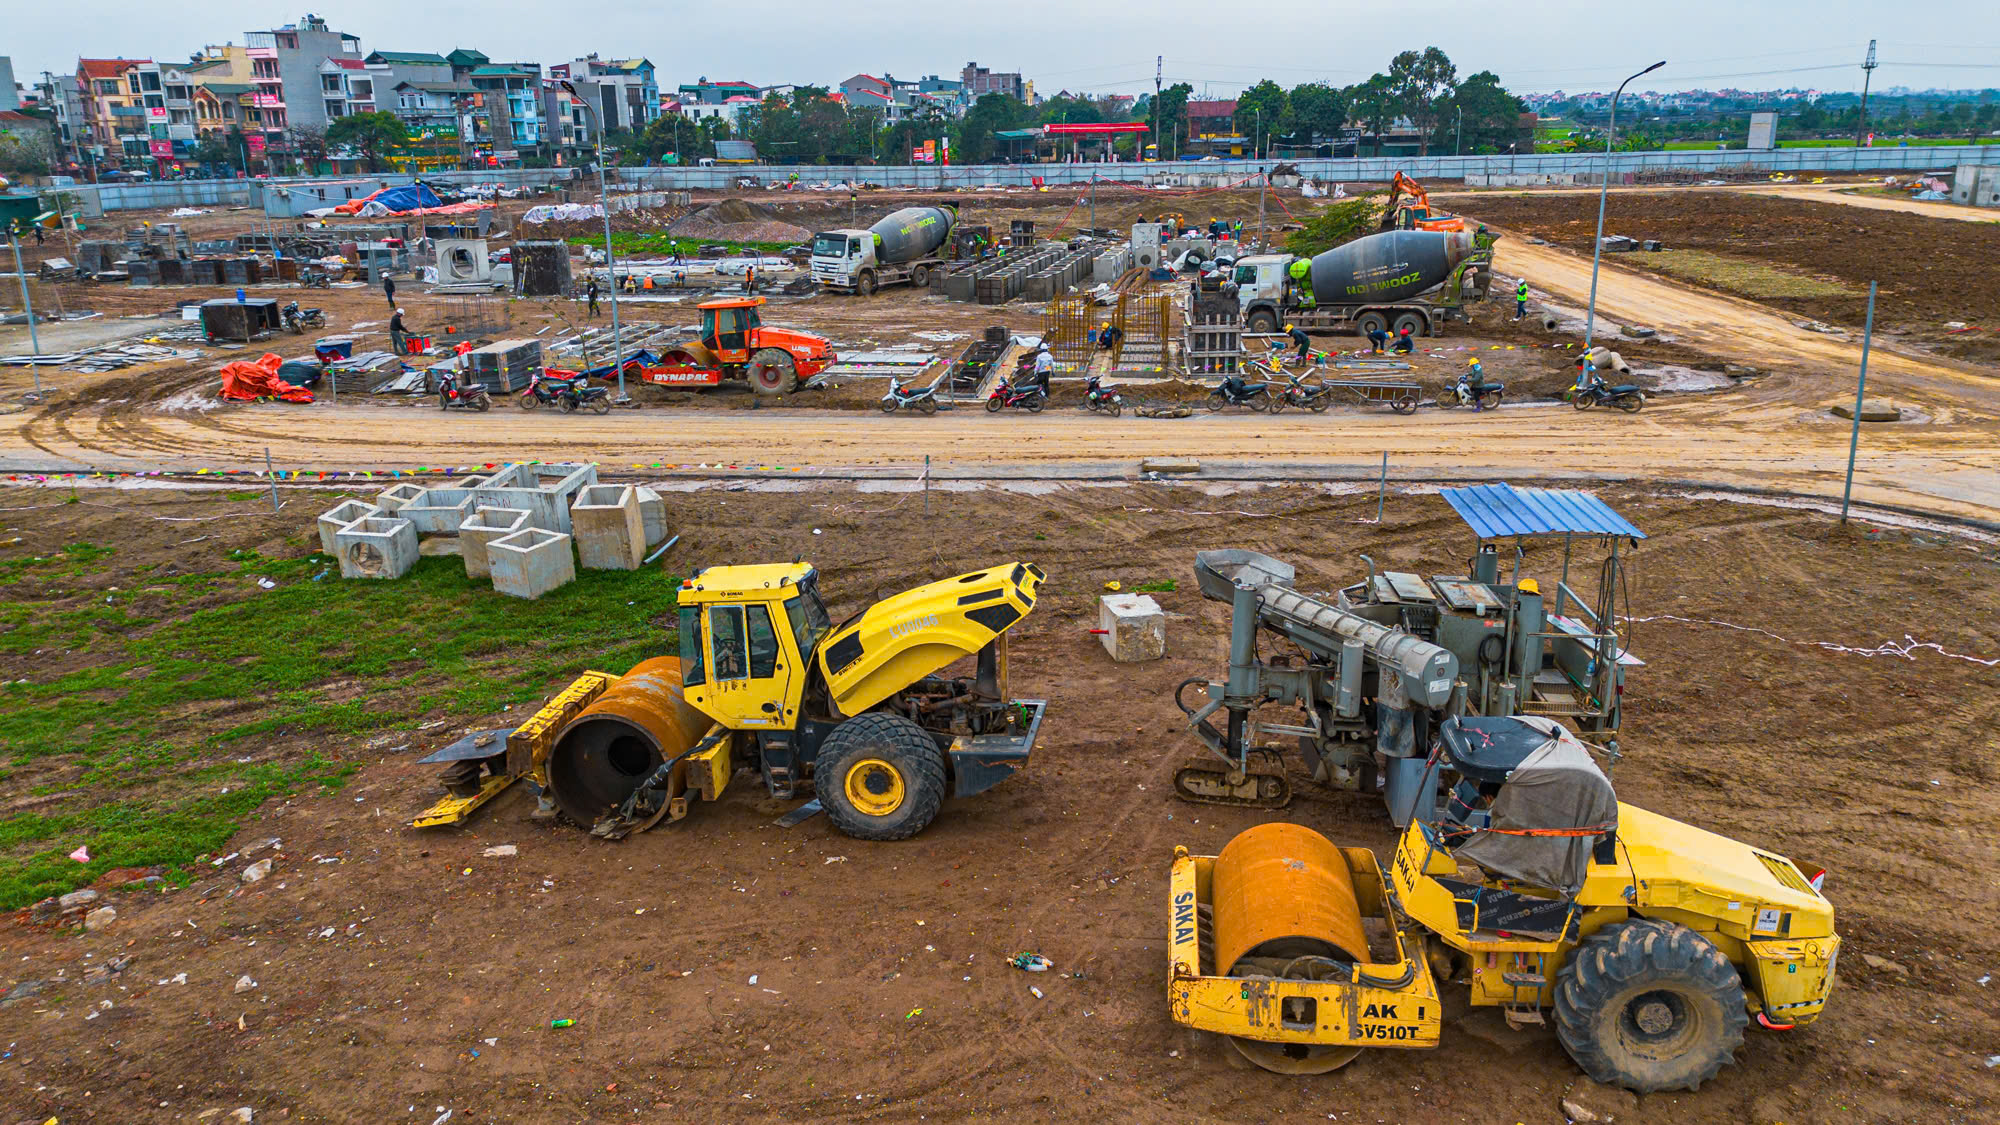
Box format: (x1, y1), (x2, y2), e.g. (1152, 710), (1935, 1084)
(1166, 849), (1444, 1049)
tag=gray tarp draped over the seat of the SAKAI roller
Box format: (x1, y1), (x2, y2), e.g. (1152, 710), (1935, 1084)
(1456, 715), (1618, 895)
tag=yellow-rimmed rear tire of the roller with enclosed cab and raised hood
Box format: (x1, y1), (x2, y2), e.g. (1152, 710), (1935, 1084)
(812, 711), (946, 841)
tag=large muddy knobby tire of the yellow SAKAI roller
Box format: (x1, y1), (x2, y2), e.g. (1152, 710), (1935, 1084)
(1556, 919), (1750, 1093)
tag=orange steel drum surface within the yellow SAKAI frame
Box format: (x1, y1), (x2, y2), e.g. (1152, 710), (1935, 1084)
(1210, 823), (1368, 977)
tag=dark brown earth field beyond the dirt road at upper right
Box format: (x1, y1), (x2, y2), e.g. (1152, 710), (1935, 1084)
(1458, 192), (2000, 362)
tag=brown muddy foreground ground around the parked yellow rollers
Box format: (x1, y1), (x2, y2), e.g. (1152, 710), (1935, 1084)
(0, 482), (2000, 1125)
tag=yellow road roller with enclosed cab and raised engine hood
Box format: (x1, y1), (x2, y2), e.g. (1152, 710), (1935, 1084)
(416, 563), (1046, 841)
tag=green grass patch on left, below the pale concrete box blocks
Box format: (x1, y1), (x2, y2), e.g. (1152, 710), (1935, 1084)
(0, 544), (676, 909)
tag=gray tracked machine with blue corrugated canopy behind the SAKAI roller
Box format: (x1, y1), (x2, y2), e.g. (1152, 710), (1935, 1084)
(1174, 476), (1644, 825)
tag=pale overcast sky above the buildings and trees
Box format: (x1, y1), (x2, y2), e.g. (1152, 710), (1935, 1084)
(0, 0), (2000, 96)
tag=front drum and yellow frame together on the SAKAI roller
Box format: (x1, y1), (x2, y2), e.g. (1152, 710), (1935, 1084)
(1168, 823), (1442, 1073)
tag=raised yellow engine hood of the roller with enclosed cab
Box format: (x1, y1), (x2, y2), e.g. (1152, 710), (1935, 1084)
(818, 563), (1042, 715)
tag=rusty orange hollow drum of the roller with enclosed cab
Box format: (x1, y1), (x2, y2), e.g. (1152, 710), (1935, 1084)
(548, 657), (712, 829)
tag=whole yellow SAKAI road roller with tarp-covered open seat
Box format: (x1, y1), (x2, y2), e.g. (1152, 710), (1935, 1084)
(1168, 717), (1840, 1093)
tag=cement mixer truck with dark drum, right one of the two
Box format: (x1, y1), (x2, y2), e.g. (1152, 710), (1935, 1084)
(1234, 230), (1496, 336)
